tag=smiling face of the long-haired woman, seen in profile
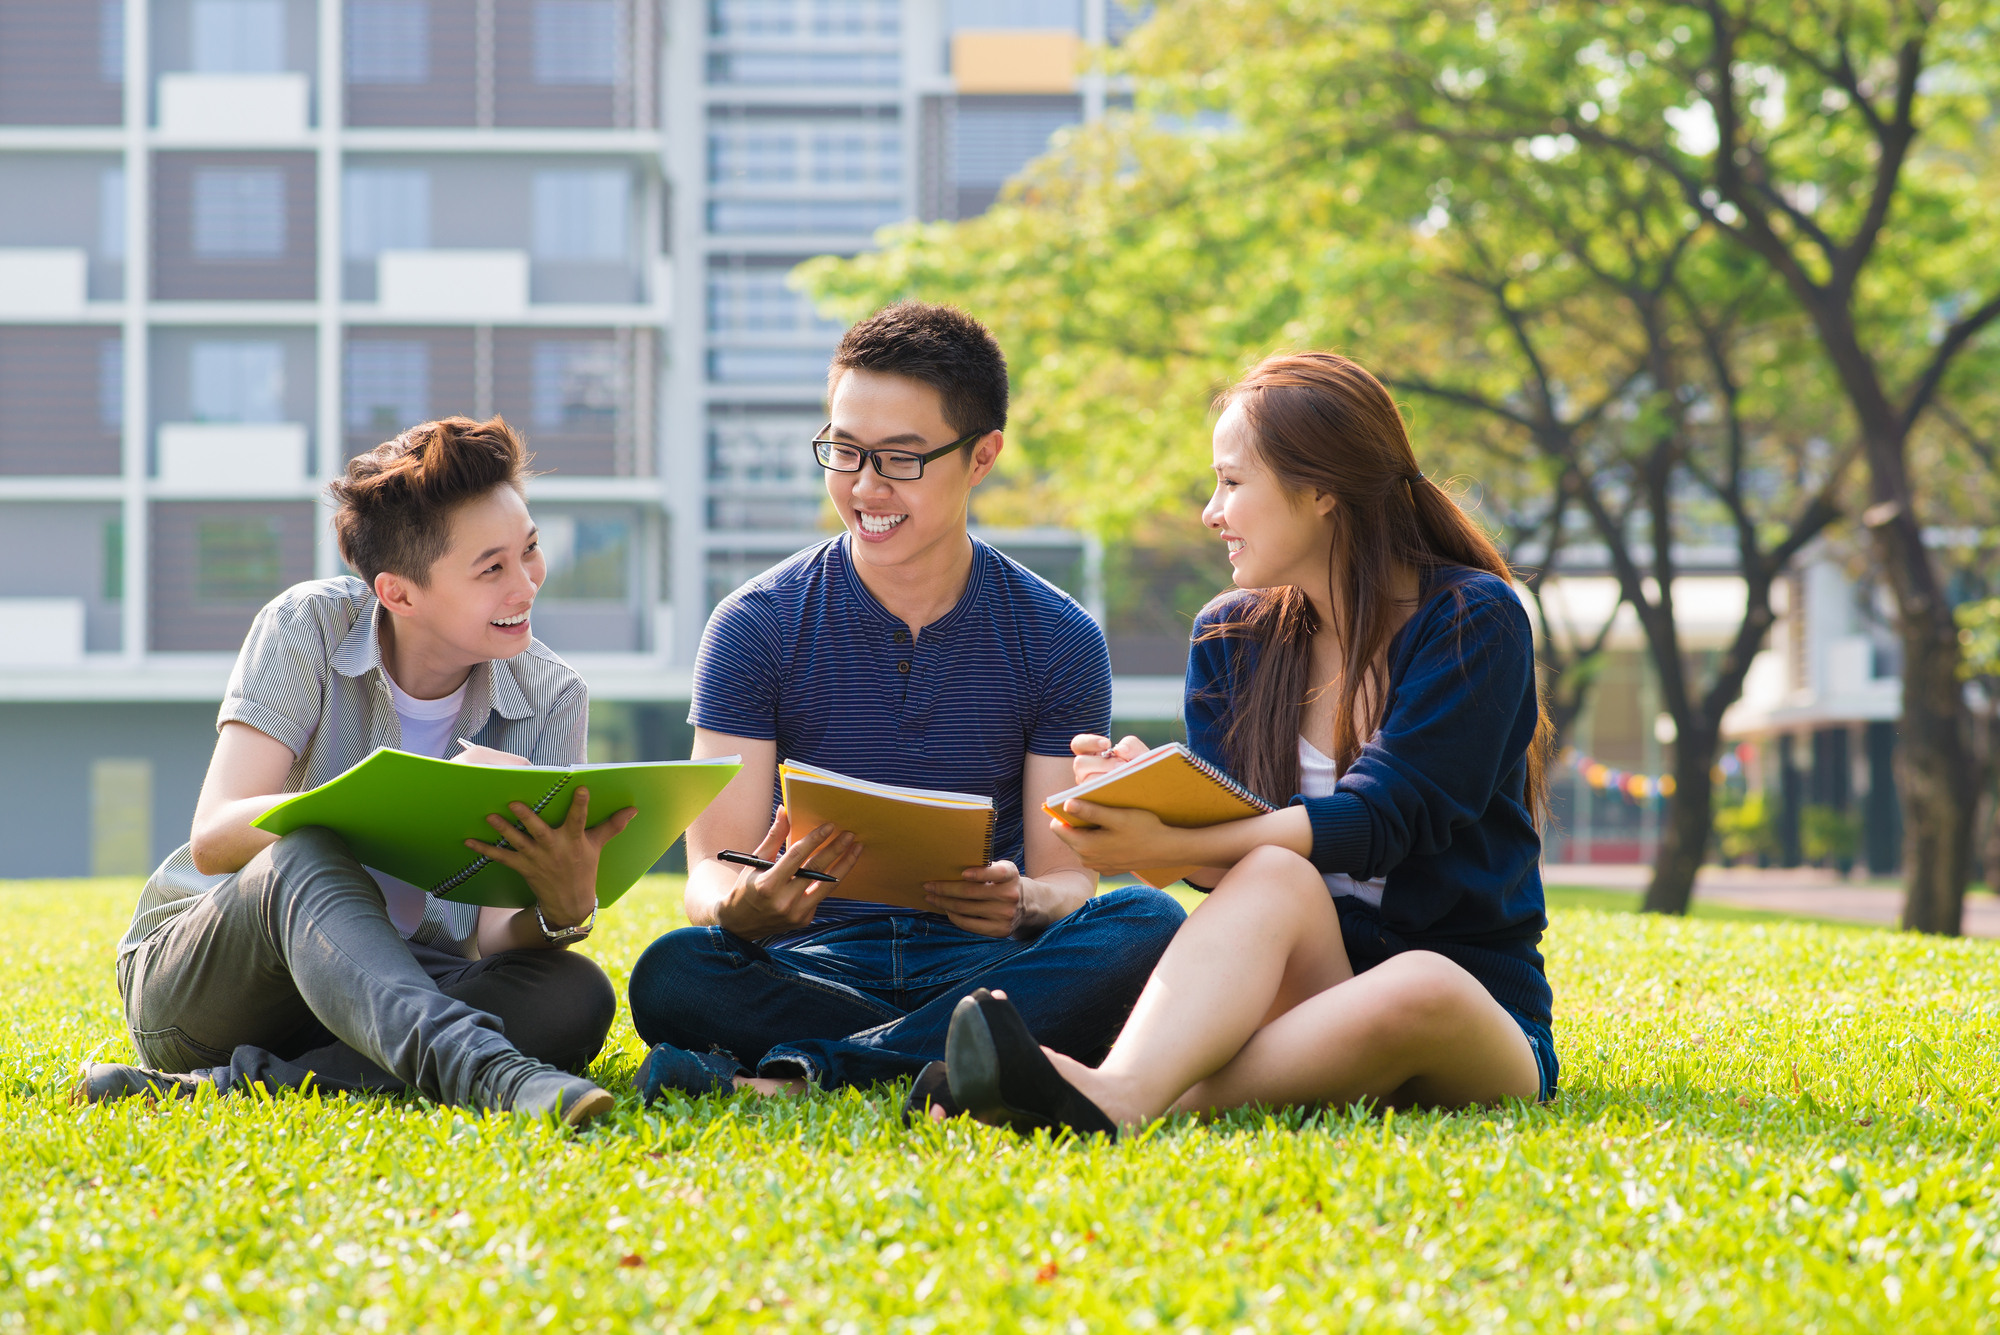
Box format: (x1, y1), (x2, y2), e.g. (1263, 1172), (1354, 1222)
(1202, 402), (1334, 590)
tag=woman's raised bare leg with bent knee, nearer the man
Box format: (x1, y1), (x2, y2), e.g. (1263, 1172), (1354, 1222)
(1044, 847), (1352, 1123)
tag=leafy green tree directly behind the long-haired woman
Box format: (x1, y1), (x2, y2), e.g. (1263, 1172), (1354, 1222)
(802, 4), (1852, 911)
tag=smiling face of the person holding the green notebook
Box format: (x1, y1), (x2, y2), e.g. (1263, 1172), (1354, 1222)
(376, 486), (548, 689)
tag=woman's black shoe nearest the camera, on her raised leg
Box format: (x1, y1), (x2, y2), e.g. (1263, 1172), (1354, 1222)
(944, 987), (1118, 1139)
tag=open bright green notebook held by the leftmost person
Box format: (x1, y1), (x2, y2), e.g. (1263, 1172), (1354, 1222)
(252, 745), (742, 907)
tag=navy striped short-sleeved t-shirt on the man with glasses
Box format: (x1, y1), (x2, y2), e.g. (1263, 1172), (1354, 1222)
(688, 534), (1112, 927)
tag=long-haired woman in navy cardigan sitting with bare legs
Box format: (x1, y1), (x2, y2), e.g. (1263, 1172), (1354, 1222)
(946, 352), (1558, 1133)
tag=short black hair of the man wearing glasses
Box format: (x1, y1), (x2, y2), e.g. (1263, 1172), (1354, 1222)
(826, 302), (1006, 448)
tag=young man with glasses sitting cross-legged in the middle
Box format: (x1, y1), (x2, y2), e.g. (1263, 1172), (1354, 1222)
(630, 302), (1184, 1115)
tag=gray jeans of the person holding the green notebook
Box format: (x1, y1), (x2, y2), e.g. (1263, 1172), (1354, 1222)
(118, 829), (618, 1109)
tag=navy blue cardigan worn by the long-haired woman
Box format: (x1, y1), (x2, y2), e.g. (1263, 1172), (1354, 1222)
(1184, 570), (1552, 1025)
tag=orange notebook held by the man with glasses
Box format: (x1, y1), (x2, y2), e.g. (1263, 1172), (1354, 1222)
(778, 759), (994, 913)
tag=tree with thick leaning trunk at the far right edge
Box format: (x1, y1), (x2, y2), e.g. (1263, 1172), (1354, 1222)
(1308, 0), (2000, 931)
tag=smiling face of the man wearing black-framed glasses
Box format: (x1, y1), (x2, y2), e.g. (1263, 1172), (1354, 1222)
(826, 370), (1000, 570)
